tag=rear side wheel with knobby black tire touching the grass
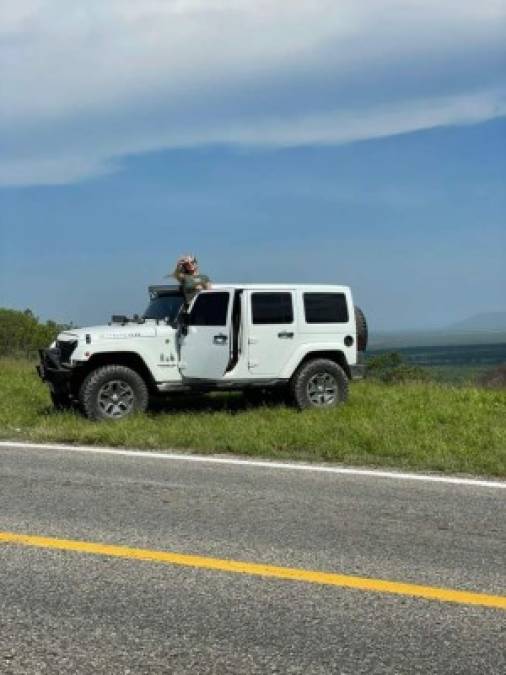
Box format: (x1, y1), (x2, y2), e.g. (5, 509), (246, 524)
(290, 359), (348, 410)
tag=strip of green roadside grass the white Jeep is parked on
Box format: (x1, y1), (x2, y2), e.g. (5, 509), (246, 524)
(0, 360), (506, 477)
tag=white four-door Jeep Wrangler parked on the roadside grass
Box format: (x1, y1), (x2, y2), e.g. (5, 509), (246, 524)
(37, 284), (367, 419)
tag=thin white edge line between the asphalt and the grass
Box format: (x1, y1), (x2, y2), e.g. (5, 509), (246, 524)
(0, 441), (506, 490)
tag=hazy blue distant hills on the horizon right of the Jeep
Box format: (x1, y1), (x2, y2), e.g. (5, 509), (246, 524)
(369, 312), (506, 349)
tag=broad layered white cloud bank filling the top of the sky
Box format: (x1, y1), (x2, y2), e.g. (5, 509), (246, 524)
(0, 0), (506, 184)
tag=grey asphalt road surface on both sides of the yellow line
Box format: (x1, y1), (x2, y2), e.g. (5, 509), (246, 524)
(0, 448), (506, 675)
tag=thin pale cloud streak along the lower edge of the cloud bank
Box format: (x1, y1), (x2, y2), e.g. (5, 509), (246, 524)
(0, 91), (506, 186)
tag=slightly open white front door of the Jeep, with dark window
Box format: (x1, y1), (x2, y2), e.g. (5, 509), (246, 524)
(180, 288), (234, 380)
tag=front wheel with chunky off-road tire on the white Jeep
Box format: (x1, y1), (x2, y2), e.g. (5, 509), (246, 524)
(79, 365), (149, 420)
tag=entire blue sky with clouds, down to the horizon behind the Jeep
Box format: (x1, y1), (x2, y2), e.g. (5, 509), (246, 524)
(0, 0), (506, 330)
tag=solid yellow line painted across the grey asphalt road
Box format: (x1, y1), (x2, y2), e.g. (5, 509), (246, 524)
(0, 532), (506, 610)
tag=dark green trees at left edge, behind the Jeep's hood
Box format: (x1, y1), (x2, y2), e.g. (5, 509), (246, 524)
(0, 307), (72, 358)
